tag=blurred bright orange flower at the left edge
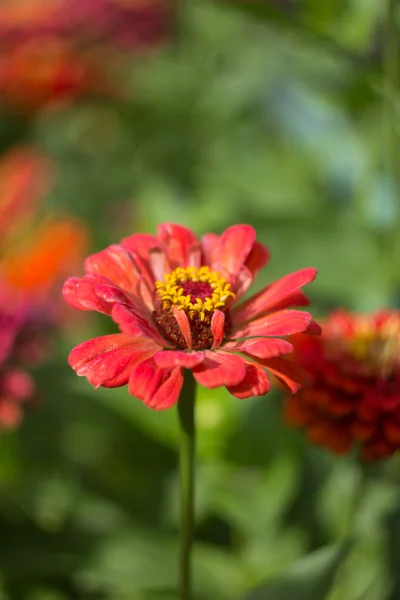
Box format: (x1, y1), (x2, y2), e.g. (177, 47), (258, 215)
(0, 148), (87, 295)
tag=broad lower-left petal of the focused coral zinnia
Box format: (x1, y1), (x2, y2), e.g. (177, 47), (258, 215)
(68, 333), (159, 387)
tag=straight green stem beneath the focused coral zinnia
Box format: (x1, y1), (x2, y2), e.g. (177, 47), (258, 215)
(178, 370), (196, 600)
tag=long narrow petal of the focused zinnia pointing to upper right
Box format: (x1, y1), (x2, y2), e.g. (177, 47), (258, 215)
(232, 268), (317, 323)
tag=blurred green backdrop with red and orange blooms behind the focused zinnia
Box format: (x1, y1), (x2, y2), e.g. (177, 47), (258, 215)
(0, 0), (400, 600)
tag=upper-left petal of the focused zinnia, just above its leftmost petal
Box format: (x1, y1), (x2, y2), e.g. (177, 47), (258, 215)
(84, 244), (140, 292)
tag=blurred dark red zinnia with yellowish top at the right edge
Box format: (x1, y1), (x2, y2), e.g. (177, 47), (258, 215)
(285, 310), (400, 461)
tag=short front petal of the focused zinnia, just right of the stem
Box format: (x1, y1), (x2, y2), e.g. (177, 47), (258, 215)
(193, 350), (246, 388)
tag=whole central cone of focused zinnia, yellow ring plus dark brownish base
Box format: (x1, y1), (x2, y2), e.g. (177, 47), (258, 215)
(154, 266), (235, 350)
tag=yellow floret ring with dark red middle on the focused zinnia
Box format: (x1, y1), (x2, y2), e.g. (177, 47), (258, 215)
(156, 267), (235, 321)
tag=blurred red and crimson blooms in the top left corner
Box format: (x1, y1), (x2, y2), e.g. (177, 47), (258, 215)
(0, 0), (171, 113)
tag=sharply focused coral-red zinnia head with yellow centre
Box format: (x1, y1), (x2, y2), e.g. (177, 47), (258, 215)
(63, 223), (319, 409)
